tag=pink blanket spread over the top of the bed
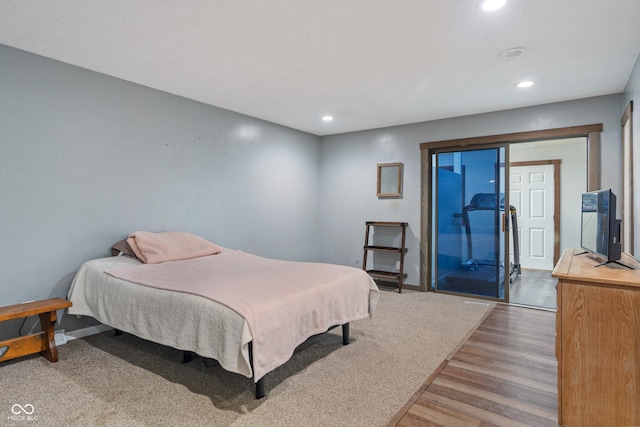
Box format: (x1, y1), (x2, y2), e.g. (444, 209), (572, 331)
(106, 251), (379, 382)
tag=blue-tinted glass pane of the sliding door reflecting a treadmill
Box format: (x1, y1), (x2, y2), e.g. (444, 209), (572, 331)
(431, 146), (509, 301)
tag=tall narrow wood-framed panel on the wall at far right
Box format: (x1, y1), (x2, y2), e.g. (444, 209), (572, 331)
(621, 101), (635, 256)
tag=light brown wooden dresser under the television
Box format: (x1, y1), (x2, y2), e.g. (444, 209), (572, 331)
(552, 249), (640, 427)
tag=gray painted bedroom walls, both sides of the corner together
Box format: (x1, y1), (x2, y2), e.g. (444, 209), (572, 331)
(0, 41), (640, 336)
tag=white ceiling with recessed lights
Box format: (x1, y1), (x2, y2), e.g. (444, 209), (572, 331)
(0, 0), (640, 135)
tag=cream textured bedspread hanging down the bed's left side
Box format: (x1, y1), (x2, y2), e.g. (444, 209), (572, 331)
(68, 256), (253, 378)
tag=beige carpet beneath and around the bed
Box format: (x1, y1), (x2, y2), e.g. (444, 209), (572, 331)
(0, 291), (493, 427)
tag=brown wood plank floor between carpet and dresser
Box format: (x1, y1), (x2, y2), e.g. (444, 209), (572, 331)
(388, 304), (558, 427)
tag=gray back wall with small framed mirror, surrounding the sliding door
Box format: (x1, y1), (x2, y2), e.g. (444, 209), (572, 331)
(318, 94), (622, 285)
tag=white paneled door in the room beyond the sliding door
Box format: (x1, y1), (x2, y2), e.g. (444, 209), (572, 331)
(509, 164), (554, 270)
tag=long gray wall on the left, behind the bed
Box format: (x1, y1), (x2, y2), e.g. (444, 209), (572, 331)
(0, 45), (319, 336)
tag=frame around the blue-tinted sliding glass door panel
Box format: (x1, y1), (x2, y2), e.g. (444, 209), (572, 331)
(427, 142), (510, 303)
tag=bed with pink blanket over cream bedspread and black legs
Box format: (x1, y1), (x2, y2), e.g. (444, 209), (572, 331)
(68, 232), (379, 398)
